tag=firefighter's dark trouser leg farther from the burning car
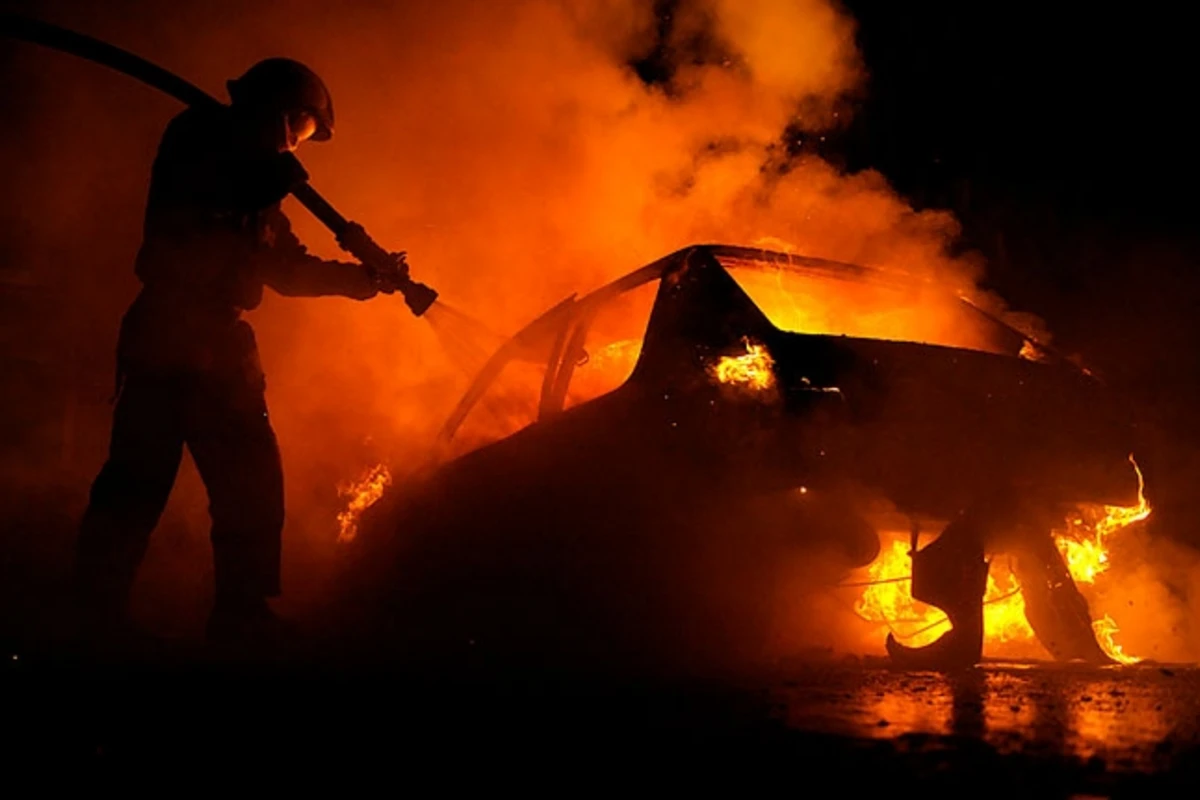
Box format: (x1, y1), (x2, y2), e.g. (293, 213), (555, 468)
(74, 375), (184, 625)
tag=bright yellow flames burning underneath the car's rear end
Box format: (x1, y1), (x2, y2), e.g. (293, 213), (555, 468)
(854, 456), (1151, 663)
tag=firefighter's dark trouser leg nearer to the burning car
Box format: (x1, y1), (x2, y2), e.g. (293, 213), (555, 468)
(187, 381), (283, 615)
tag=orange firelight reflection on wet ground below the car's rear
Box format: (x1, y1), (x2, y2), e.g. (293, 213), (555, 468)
(782, 664), (1200, 769)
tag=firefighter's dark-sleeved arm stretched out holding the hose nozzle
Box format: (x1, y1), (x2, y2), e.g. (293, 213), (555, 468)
(258, 209), (379, 300)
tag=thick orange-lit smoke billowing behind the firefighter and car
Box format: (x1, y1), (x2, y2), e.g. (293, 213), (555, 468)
(4, 0), (1142, 652)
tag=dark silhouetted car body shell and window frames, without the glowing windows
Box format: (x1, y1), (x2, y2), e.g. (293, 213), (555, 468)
(336, 246), (1138, 667)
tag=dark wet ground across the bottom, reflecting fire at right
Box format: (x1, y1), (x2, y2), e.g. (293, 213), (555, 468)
(0, 654), (1200, 798)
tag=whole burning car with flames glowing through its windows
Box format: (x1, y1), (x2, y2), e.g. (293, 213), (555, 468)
(333, 246), (1148, 667)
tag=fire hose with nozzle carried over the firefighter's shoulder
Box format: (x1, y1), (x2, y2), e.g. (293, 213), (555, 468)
(0, 14), (438, 317)
